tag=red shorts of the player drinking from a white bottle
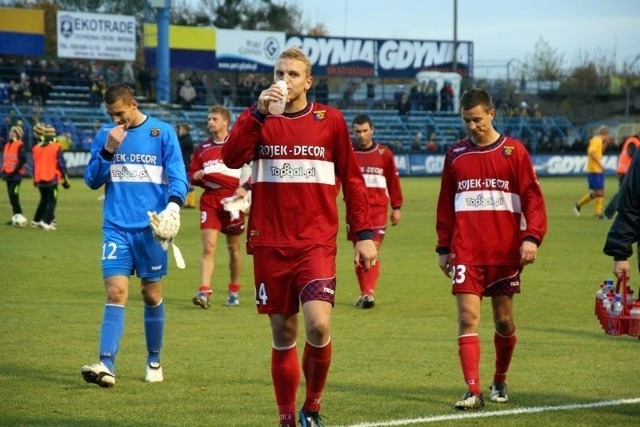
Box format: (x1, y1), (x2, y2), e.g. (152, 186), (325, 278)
(253, 245), (337, 314)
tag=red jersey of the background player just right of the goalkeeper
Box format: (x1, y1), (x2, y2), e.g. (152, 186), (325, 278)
(188, 137), (241, 197)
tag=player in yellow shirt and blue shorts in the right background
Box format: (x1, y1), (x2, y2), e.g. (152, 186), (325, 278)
(573, 125), (613, 219)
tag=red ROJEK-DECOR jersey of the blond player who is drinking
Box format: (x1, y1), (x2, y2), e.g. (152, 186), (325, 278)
(222, 103), (371, 250)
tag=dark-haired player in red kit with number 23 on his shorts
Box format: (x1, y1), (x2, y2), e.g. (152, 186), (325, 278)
(436, 89), (547, 410)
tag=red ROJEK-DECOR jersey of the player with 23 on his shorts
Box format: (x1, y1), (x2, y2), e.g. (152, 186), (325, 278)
(436, 136), (547, 265)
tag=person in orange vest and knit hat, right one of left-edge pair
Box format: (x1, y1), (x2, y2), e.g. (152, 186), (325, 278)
(31, 123), (69, 231)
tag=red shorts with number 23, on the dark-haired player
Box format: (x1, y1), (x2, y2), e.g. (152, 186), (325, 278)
(451, 264), (522, 297)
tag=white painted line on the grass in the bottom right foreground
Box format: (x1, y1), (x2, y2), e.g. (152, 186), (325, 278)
(336, 397), (640, 427)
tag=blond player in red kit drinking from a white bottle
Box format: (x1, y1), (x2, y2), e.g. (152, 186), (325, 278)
(222, 47), (377, 427)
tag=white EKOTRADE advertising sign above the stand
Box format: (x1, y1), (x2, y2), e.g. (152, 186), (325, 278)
(57, 12), (136, 61)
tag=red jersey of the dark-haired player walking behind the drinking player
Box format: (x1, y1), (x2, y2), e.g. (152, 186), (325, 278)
(354, 143), (402, 227)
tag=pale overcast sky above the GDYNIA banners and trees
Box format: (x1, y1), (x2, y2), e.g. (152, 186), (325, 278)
(296, 0), (640, 75)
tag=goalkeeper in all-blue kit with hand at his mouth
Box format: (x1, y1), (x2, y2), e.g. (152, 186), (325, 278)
(81, 83), (187, 387)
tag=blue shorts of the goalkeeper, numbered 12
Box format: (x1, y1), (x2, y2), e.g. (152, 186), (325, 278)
(102, 225), (167, 282)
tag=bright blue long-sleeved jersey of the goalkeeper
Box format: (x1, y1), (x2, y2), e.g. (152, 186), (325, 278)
(84, 116), (187, 230)
